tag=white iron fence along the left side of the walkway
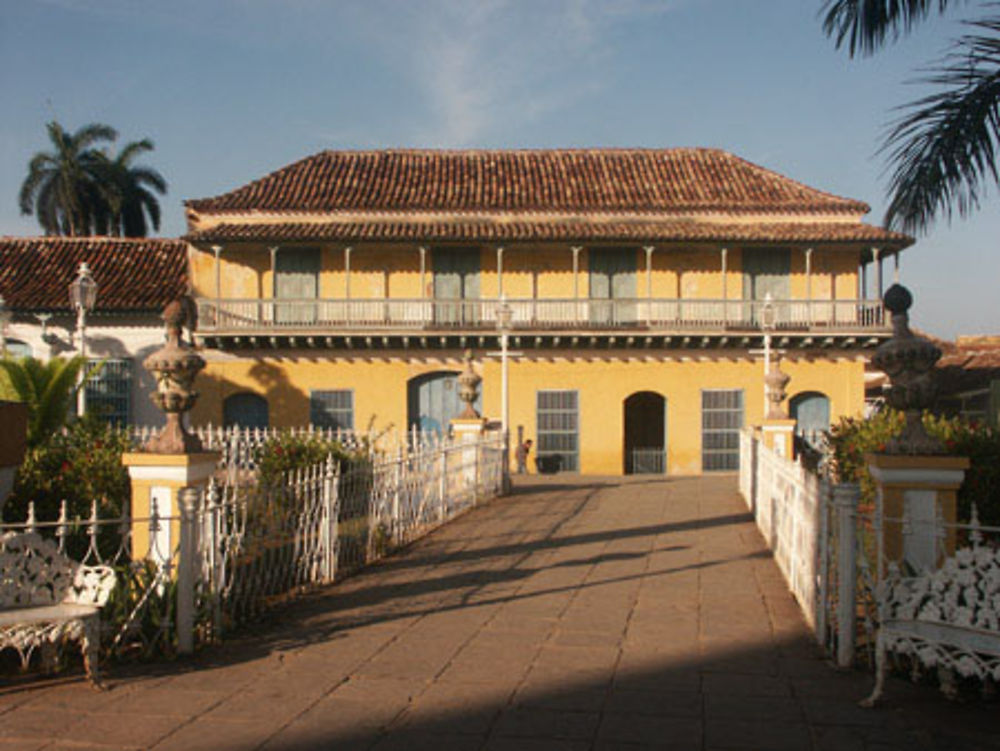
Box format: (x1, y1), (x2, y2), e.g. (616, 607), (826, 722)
(0, 433), (506, 654)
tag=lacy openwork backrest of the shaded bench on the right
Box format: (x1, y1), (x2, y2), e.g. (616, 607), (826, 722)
(879, 545), (1000, 633)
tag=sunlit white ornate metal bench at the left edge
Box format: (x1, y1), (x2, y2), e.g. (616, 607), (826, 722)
(0, 532), (115, 687)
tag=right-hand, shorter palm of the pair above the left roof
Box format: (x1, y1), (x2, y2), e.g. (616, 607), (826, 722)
(100, 138), (167, 237)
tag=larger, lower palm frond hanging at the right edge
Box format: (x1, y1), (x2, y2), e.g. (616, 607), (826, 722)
(881, 18), (1000, 232)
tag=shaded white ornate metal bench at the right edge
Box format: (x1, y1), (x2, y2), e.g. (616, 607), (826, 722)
(861, 544), (1000, 707)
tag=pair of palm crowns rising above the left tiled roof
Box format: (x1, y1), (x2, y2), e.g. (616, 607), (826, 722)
(19, 120), (167, 237)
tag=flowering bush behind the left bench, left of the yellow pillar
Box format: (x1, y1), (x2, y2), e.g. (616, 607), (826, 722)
(3, 416), (129, 521)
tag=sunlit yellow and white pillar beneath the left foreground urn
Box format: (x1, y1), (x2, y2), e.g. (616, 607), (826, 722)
(122, 451), (221, 562)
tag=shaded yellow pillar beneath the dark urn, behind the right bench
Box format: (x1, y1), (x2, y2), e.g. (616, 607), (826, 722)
(865, 454), (969, 571)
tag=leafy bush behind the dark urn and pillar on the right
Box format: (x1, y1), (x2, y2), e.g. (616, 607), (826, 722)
(830, 409), (1000, 526)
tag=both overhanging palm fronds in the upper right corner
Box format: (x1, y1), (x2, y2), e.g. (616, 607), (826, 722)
(823, 0), (1000, 232)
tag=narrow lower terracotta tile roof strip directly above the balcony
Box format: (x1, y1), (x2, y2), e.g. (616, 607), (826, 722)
(186, 219), (913, 247)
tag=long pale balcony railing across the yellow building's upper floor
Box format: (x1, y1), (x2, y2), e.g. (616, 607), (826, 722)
(198, 298), (886, 333)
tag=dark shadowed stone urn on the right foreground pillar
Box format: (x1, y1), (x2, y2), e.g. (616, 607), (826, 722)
(872, 284), (944, 455)
